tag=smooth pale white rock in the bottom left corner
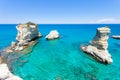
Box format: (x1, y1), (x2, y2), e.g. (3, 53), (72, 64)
(0, 63), (23, 80)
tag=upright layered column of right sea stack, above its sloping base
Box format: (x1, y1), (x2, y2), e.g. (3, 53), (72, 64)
(90, 27), (110, 50)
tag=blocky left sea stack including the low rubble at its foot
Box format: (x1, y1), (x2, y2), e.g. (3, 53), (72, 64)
(5, 22), (42, 53)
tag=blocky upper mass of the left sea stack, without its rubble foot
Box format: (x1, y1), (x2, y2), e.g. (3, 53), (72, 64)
(16, 22), (42, 45)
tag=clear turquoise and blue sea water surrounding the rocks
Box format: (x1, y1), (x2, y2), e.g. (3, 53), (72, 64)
(0, 24), (120, 80)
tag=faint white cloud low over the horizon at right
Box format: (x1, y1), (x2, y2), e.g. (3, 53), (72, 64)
(90, 18), (120, 24)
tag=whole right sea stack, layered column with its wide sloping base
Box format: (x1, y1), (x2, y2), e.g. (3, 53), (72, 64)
(81, 27), (113, 64)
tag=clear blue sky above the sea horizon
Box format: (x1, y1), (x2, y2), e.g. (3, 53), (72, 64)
(0, 0), (120, 24)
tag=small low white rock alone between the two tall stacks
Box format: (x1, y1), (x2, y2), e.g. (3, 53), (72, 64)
(45, 30), (60, 40)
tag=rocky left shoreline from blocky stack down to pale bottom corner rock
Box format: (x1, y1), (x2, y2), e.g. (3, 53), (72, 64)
(0, 22), (42, 80)
